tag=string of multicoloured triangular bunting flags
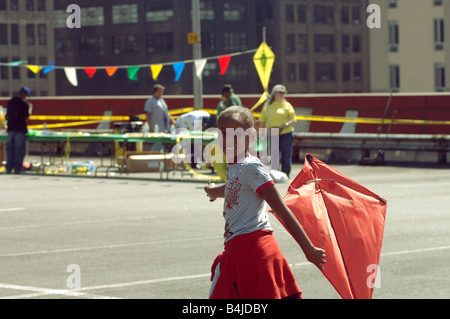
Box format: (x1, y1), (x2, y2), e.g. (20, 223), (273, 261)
(0, 49), (257, 87)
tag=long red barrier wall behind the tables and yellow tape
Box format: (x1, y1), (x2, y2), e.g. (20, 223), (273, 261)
(0, 93), (450, 134)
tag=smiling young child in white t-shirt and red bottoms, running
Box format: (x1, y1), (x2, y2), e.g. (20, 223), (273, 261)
(205, 106), (325, 299)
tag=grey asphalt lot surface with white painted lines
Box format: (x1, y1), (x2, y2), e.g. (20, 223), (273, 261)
(0, 161), (450, 299)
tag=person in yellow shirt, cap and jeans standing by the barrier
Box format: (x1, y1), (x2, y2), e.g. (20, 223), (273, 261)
(259, 84), (297, 177)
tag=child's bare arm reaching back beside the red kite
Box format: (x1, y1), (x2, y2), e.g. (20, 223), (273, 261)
(261, 185), (326, 270)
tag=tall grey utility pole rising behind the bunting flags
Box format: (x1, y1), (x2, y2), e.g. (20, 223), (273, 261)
(191, 0), (203, 108)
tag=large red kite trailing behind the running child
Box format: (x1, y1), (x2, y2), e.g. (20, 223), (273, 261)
(274, 154), (387, 299)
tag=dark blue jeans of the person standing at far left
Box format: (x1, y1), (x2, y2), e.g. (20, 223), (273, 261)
(6, 132), (27, 174)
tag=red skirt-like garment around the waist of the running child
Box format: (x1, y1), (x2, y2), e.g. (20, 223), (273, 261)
(210, 230), (302, 299)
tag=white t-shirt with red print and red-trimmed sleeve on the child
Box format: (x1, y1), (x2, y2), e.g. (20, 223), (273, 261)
(223, 156), (274, 242)
